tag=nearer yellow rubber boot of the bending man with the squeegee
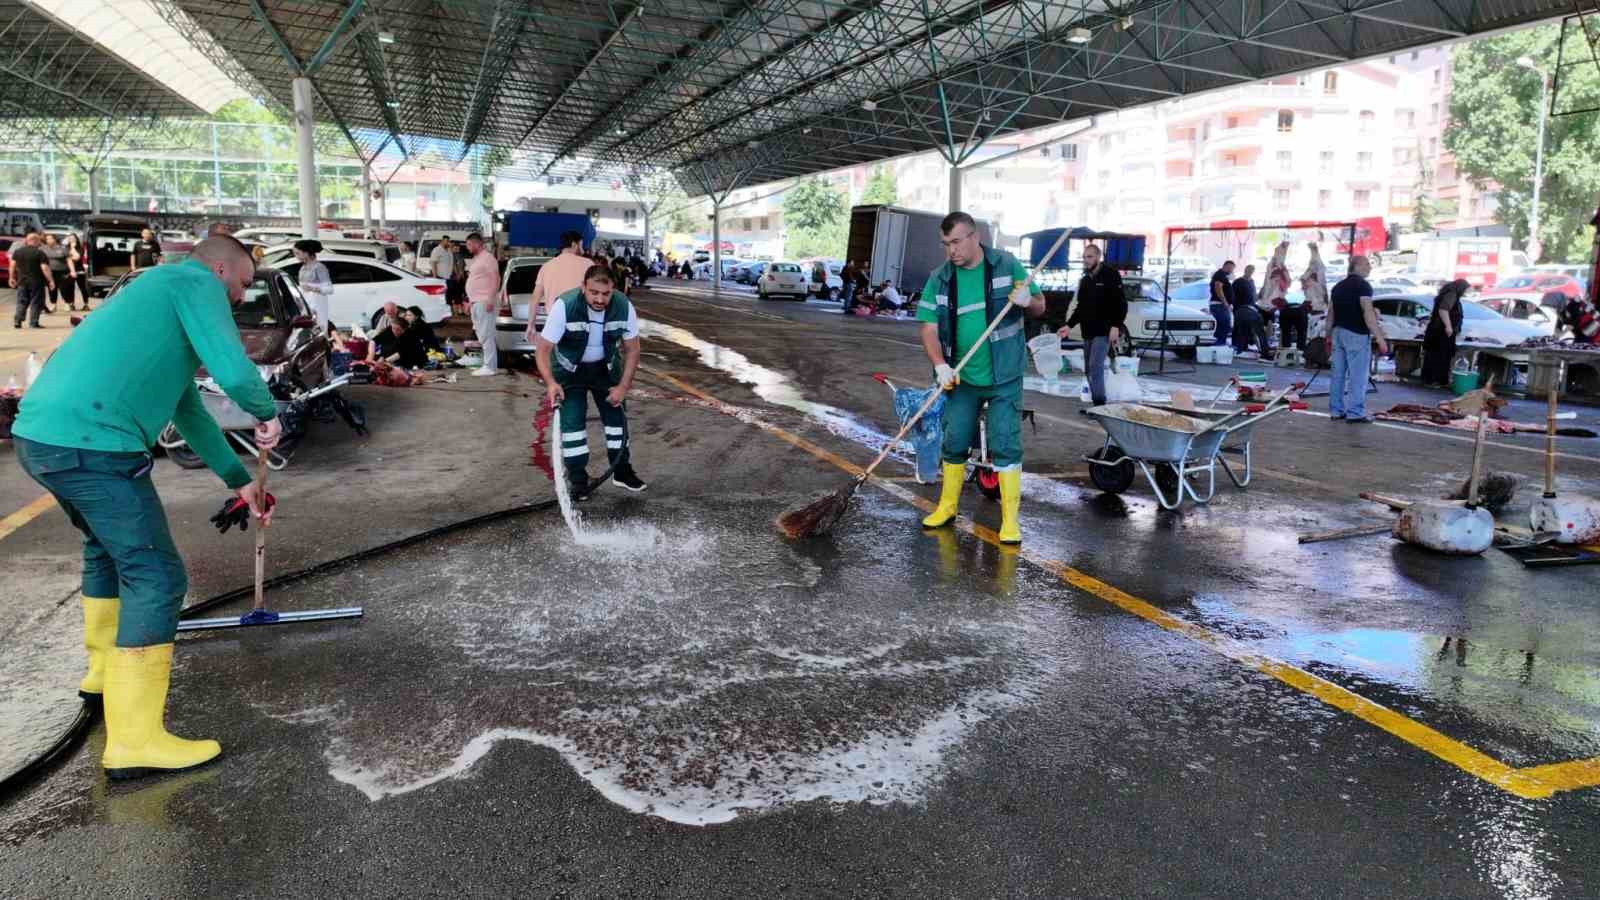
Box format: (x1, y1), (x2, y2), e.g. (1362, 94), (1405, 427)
(101, 644), (222, 780)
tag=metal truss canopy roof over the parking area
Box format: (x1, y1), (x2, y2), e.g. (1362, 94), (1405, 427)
(0, 0), (1571, 194)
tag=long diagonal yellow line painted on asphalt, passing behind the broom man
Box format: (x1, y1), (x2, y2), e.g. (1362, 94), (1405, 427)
(640, 367), (1600, 799)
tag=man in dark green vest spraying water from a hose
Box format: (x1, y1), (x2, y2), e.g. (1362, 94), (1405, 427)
(534, 264), (646, 500)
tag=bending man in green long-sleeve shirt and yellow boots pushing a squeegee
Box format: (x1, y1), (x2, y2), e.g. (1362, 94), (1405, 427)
(13, 235), (282, 778)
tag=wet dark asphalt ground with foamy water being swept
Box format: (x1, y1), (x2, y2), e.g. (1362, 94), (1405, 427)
(0, 278), (1600, 898)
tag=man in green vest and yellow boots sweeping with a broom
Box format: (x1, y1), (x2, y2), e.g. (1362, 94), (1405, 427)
(917, 213), (1045, 544)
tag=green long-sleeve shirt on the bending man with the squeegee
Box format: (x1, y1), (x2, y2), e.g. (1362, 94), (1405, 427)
(11, 259), (277, 488)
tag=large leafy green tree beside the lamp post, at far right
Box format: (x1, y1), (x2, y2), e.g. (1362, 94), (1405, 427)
(1445, 24), (1600, 259)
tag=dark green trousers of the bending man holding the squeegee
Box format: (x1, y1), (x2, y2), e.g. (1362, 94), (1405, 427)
(16, 437), (189, 647)
